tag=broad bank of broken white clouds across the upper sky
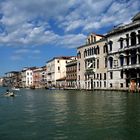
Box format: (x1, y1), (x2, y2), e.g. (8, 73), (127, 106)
(0, 0), (140, 48)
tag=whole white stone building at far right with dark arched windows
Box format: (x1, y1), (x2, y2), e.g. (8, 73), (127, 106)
(107, 13), (140, 90)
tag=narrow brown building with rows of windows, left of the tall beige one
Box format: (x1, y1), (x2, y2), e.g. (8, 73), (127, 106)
(66, 57), (77, 88)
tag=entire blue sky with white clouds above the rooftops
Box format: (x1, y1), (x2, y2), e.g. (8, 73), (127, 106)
(0, 0), (140, 76)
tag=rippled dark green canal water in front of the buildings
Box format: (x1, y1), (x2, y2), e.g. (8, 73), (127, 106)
(0, 88), (140, 140)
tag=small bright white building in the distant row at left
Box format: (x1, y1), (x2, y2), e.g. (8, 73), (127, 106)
(21, 67), (36, 87)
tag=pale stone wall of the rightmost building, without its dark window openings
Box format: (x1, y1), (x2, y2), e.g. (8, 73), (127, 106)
(107, 17), (140, 90)
